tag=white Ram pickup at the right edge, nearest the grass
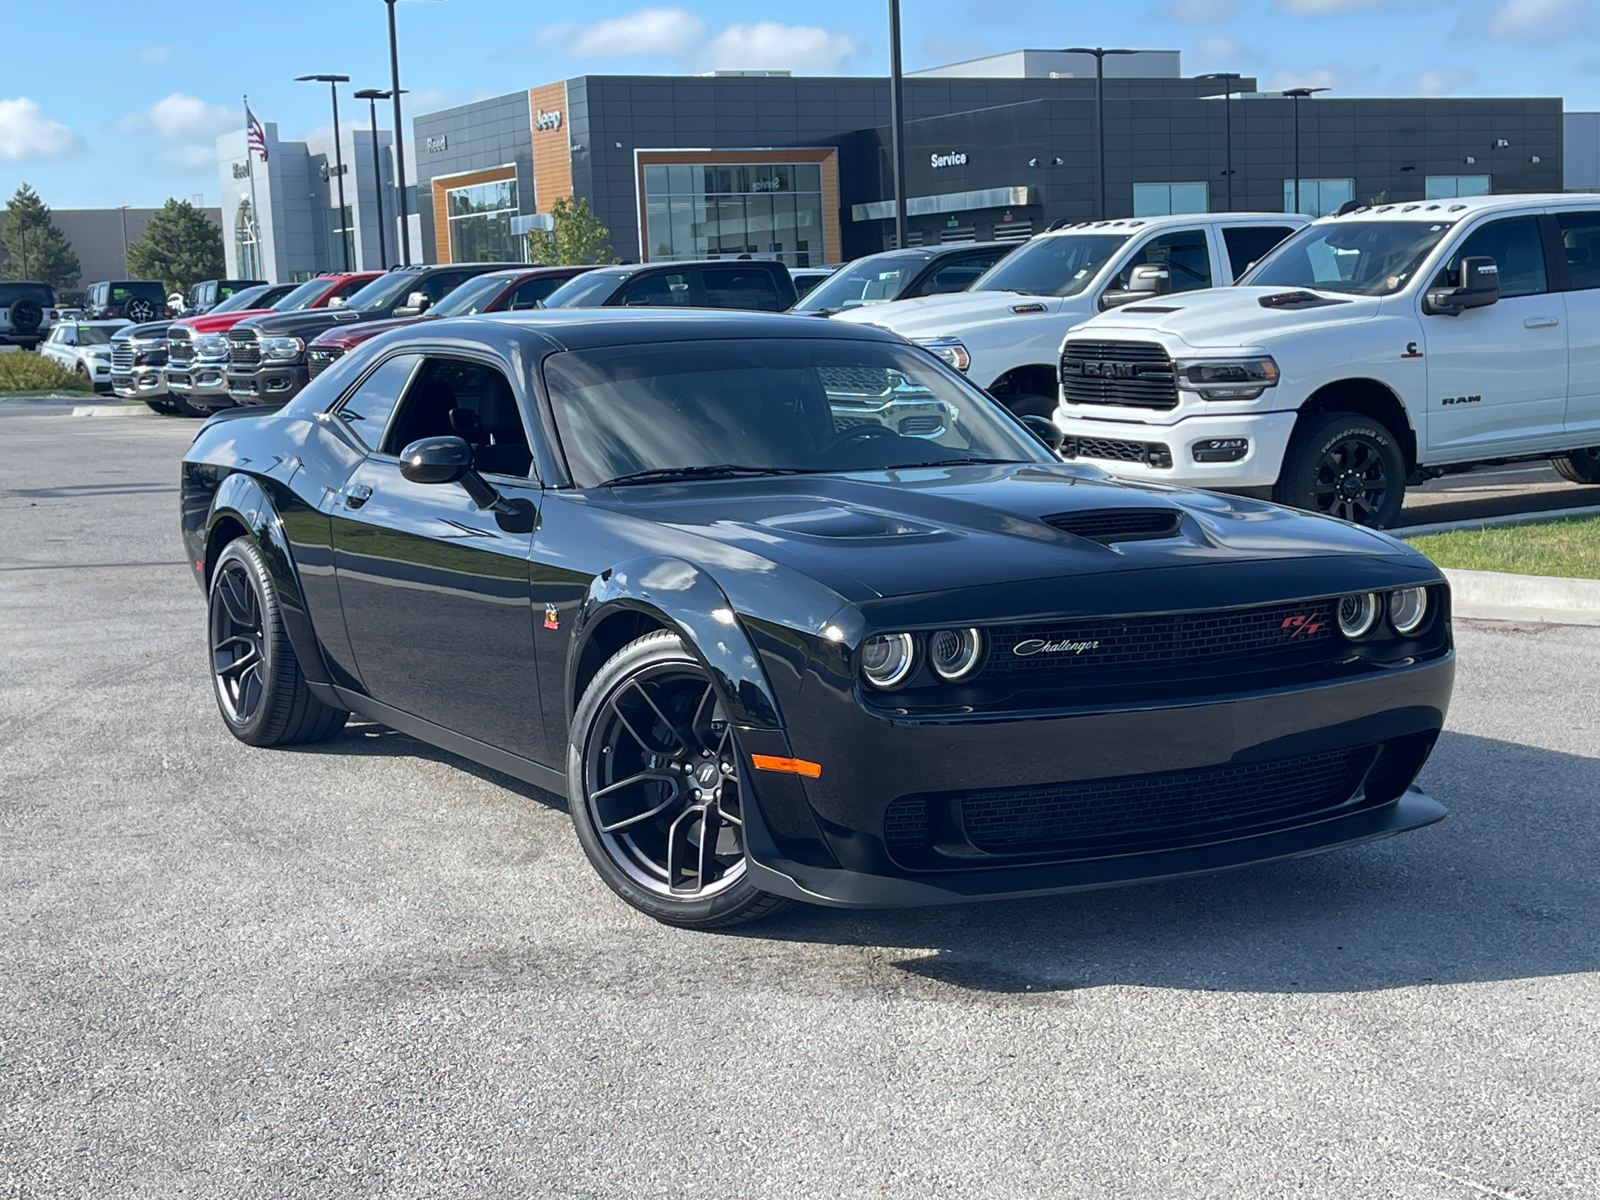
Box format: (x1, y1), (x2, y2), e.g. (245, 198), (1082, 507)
(1054, 195), (1600, 528)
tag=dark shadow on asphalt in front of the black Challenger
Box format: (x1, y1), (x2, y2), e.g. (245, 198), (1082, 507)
(728, 733), (1600, 994)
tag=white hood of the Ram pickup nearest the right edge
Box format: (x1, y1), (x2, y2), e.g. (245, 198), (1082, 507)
(1067, 286), (1382, 347)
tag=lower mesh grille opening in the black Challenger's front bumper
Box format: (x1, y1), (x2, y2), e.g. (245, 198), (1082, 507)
(883, 746), (1394, 856)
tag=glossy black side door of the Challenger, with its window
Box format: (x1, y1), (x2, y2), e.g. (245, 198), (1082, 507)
(330, 354), (546, 762)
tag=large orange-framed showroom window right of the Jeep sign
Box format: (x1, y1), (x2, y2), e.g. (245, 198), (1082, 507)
(645, 163), (822, 267)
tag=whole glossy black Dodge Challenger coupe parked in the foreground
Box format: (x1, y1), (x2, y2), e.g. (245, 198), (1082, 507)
(182, 310), (1454, 928)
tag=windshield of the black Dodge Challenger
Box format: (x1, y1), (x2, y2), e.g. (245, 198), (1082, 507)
(544, 338), (1056, 488)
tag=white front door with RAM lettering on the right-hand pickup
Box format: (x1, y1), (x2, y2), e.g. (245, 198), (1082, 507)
(1418, 213), (1566, 461)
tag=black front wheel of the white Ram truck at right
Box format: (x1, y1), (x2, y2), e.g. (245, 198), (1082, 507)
(1272, 413), (1405, 530)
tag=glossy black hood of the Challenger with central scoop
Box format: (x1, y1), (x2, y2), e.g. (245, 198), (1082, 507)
(595, 462), (1437, 606)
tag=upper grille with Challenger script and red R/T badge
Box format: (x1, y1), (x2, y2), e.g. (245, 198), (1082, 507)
(984, 598), (1346, 682)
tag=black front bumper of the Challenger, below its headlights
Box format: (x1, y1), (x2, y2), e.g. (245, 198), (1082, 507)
(741, 653), (1454, 907)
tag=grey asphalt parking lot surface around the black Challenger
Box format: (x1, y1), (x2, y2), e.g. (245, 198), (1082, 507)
(9, 403), (1600, 1200)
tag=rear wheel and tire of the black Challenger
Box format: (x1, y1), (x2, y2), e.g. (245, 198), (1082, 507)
(206, 538), (350, 746)
